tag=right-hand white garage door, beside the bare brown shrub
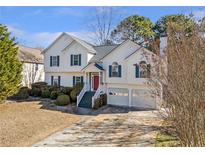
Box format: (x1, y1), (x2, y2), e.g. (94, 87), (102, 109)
(131, 89), (156, 109)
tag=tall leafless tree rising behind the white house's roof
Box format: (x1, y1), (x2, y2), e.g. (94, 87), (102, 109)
(89, 7), (116, 45)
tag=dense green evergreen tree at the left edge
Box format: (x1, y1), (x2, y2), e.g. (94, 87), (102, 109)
(0, 24), (22, 102)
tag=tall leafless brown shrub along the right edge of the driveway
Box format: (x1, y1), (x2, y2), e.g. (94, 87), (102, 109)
(149, 18), (205, 146)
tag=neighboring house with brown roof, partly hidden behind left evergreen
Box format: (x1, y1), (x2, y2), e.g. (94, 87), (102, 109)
(17, 45), (45, 87)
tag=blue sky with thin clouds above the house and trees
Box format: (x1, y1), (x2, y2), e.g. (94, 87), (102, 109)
(0, 6), (205, 47)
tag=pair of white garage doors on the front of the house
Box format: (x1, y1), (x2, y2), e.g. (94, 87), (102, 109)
(108, 87), (156, 109)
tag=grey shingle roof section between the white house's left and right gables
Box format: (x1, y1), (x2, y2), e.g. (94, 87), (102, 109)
(90, 44), (118, 62)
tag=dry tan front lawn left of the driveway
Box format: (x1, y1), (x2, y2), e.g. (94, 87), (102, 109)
(0, 101), (80, 146)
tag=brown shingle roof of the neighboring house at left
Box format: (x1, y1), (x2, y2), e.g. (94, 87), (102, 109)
(17, 45), (43, 64)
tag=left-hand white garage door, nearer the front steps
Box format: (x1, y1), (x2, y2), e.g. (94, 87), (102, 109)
(108, 88), (129, 106)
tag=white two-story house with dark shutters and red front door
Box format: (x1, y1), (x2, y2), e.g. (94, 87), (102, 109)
(43, 33), (160, 109)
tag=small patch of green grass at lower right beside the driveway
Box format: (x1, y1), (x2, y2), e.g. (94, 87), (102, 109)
(155, 131), (179, 147)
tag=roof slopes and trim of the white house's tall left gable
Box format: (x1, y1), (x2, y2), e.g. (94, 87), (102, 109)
(43, 32), (96, 53)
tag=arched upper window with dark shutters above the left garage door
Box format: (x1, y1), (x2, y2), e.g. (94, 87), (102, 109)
(109, 62), (121, 77)
